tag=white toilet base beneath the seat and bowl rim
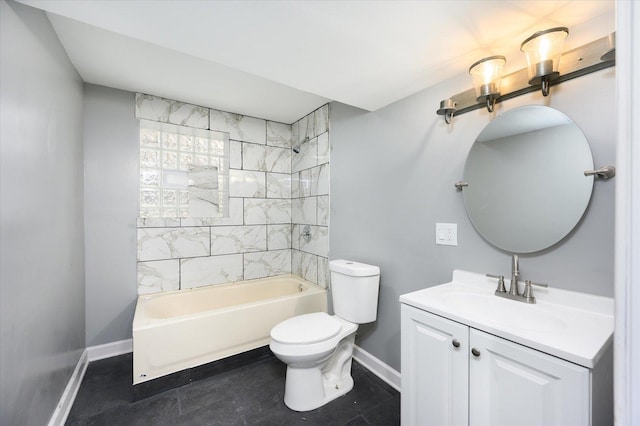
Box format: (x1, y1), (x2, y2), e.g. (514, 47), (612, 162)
(284, 333), (355, 411)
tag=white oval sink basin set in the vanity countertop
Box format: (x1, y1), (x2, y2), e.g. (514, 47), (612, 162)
(442, 291), (567, 331)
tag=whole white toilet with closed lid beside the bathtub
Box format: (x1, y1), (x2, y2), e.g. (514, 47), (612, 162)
(269, 259), (380, 411)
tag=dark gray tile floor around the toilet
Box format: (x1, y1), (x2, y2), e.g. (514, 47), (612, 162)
(66, 354), (400, 426)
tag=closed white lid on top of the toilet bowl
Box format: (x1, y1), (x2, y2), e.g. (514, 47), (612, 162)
(271, 312), (340, 345)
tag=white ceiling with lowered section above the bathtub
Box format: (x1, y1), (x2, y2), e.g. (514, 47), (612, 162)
(19, 0), (615, 123)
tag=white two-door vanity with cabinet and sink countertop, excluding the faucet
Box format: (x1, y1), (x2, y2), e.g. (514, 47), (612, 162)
(400, 270), (613, 426)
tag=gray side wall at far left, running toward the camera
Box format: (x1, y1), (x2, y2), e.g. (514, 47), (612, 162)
(0, 0), (85, 425)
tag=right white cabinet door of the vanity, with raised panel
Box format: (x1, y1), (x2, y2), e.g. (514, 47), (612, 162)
(469, 329), (590, 426)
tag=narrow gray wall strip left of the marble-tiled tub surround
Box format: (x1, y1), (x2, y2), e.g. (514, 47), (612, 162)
(83, 84), (139, 346)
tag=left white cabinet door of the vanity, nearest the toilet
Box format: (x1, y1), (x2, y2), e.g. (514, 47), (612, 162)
(401, 304), (469, 426)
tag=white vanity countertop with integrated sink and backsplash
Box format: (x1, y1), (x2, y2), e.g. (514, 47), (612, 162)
(400, 270), (614, 368)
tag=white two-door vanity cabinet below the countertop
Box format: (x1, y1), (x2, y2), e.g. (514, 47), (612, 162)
(401, 303), (613, 426)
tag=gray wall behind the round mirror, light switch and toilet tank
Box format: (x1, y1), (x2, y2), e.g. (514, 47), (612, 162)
(329, 69), (616, 370)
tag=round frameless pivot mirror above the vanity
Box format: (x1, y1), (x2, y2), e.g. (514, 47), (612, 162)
(463, 106), (593, 253)
